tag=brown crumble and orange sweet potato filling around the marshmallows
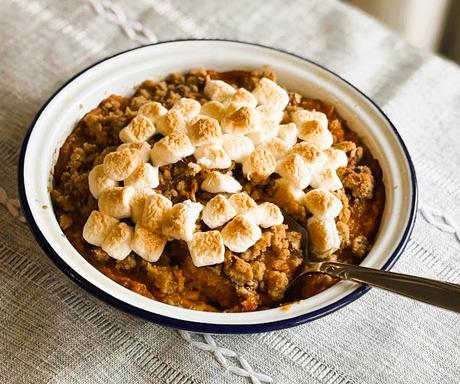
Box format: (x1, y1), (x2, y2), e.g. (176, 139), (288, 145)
(51, 70), (385, 312)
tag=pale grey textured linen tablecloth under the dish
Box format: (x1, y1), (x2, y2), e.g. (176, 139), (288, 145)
(0, 0), (460, 384)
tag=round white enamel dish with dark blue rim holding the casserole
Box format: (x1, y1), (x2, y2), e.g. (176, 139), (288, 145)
(18, 40), (417, 333)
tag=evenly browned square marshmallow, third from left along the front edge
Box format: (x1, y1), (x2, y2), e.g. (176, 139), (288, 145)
(131, 225), (167, 263)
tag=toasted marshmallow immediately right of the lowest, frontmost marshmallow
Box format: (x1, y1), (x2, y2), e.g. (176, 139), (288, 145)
(221, 215), (262, 252)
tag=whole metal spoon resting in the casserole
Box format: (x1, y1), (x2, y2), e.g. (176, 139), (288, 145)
(283, 212), (460, 312)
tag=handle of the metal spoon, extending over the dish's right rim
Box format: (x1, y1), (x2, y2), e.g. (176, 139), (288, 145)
(318, 261), (460, 312)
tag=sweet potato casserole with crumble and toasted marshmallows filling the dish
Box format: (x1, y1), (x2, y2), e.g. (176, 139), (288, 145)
(51, 69), (385, 312)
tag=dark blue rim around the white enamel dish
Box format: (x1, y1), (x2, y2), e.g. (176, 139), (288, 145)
(18, 39), (418, 334)
